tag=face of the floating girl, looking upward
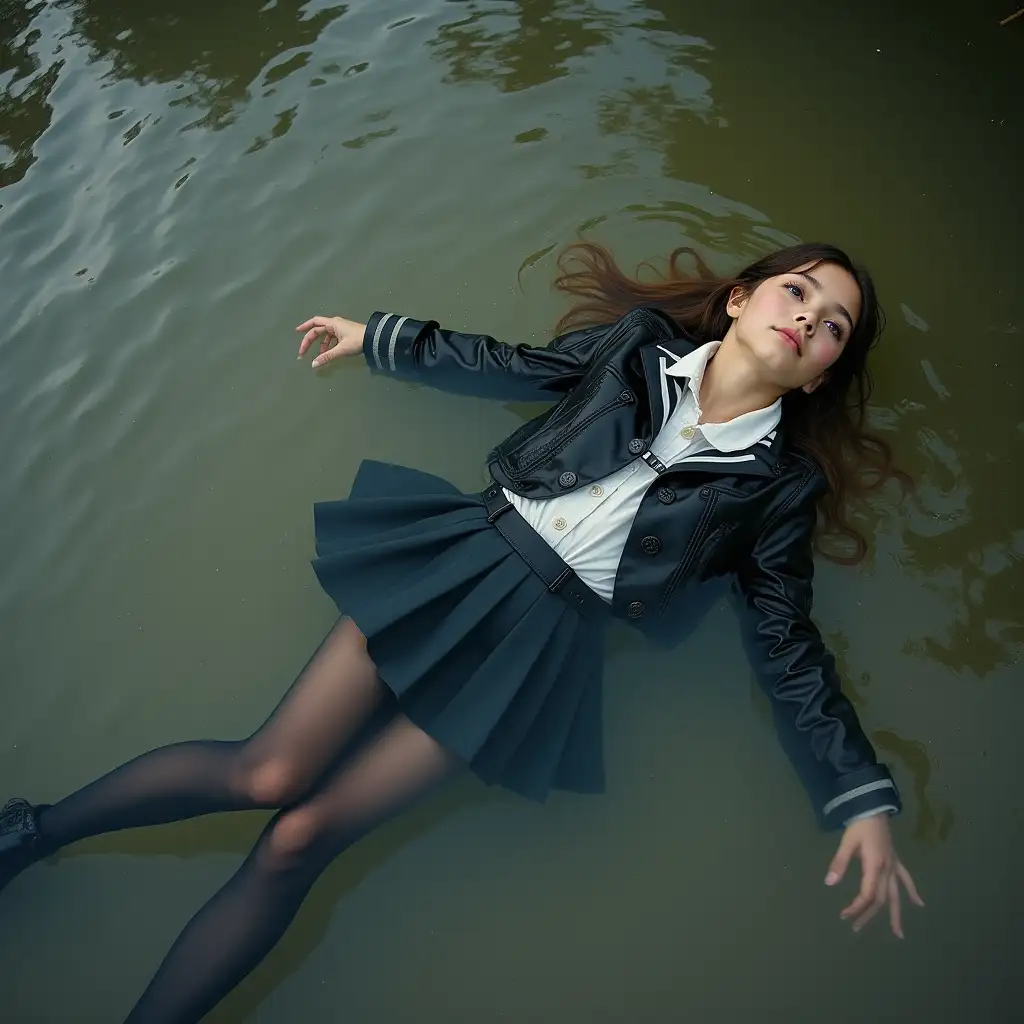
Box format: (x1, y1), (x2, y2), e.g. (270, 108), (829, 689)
(727, 263), (861, 392)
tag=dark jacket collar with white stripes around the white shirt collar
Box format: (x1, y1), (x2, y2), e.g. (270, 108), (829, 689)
(641, 338), (784, 476)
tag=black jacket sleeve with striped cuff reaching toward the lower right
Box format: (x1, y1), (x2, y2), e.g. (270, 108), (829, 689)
(737, 475), (901, 828)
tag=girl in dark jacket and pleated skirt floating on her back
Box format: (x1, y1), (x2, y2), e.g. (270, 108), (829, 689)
(0, 244), (921, 1024)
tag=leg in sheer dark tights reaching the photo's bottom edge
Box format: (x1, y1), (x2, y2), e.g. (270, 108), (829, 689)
(127, 716), (460, 1024)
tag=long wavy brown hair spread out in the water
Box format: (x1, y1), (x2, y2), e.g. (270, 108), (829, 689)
(554, 242), (910, 565)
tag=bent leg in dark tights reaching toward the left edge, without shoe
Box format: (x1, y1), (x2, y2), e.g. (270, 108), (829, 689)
(39, 618), (384, 851)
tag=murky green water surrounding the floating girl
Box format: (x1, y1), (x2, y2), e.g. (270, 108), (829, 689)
(0, 0), (1024, 1024)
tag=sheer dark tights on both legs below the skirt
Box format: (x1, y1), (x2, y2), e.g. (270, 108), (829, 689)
(39, 620), (457, 1024)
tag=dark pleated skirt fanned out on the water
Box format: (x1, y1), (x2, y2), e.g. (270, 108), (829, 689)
(312, 461), (606, 800)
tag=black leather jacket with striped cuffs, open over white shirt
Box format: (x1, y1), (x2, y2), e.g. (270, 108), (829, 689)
(364, 308), (900, 826)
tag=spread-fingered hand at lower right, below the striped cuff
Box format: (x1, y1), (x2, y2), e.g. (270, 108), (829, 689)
(825, 812), (925, 939)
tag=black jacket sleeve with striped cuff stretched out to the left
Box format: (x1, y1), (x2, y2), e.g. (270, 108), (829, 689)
(362, 312), (608, 401)
